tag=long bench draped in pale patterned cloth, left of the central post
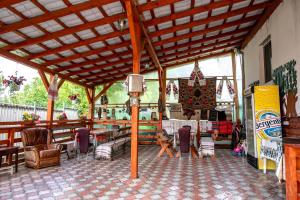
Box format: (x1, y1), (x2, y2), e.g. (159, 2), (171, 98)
(96, 127), (131, 160)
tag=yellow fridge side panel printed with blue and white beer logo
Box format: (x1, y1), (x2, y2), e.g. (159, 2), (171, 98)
(254, 85), (282, 169)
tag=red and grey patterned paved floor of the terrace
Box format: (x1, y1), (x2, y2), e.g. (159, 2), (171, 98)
(0, 146), (285, 200)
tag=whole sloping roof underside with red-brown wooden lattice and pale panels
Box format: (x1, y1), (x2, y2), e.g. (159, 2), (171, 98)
(0, 0), (282, 87)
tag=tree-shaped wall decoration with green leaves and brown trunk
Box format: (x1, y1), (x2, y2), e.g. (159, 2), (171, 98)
(273, 60), (298, 117)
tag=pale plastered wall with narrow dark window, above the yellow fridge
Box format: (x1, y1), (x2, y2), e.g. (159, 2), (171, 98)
(243, 0), (300, 114)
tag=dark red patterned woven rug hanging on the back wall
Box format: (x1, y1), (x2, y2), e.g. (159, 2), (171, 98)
(178, 78), (216, 110)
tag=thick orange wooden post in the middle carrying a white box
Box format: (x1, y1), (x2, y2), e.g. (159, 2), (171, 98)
(125, 0), (142, 179)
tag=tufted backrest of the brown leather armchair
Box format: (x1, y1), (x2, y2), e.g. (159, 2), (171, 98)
(21, 128), (50, 147)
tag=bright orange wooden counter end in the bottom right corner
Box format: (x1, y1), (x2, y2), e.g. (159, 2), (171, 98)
(284, 144), (300, 200)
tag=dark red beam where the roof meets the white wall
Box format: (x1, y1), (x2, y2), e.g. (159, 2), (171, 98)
(241, 0), (282, 49)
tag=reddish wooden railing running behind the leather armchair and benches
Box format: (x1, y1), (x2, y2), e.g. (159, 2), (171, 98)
(0, 120), (160, 146)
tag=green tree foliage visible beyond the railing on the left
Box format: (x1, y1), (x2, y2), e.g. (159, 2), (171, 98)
(0, 76), (158, 115)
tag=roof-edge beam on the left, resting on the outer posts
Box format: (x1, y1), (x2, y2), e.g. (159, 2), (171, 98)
(0, 49), (91, 88)
